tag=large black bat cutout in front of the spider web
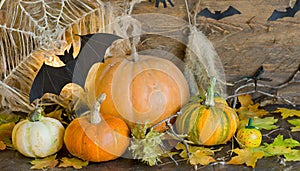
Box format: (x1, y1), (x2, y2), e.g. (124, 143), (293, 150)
(29, 33), (120, 103)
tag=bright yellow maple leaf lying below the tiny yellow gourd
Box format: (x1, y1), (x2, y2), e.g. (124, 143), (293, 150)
(227, 148), (264, 168)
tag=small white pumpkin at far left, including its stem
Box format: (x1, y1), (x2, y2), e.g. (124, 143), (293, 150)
(12, 108), (65, 158)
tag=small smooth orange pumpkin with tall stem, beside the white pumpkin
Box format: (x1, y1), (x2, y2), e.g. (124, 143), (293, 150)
(64, 94), (130, 162)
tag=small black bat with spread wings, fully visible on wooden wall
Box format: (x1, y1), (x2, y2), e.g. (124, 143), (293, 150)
(198, 6), (241, 20)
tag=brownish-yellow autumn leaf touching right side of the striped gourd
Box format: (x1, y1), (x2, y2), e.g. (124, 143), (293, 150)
(236, 95), (269, 120)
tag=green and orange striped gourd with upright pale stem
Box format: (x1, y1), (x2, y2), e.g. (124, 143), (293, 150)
(175, 78), (238, 146)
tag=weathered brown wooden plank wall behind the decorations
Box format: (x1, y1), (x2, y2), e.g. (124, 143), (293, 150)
(134, 0), (300, 104)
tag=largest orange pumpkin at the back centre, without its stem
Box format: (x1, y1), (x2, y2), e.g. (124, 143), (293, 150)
(90, 55), (190, 130)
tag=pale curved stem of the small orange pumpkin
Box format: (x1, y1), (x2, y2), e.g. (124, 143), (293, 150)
(90, 93), (106, 124)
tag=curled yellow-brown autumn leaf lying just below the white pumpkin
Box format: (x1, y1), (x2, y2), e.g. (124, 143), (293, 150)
(30, 154), (58, 169)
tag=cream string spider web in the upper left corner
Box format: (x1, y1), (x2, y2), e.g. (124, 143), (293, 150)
(0, 0), (116, 112)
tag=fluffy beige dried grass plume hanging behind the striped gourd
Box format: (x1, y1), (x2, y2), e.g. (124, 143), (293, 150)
(184, 26), (226, 96)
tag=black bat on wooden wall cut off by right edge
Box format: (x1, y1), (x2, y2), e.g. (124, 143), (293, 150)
(268, 0), (300, 21)
